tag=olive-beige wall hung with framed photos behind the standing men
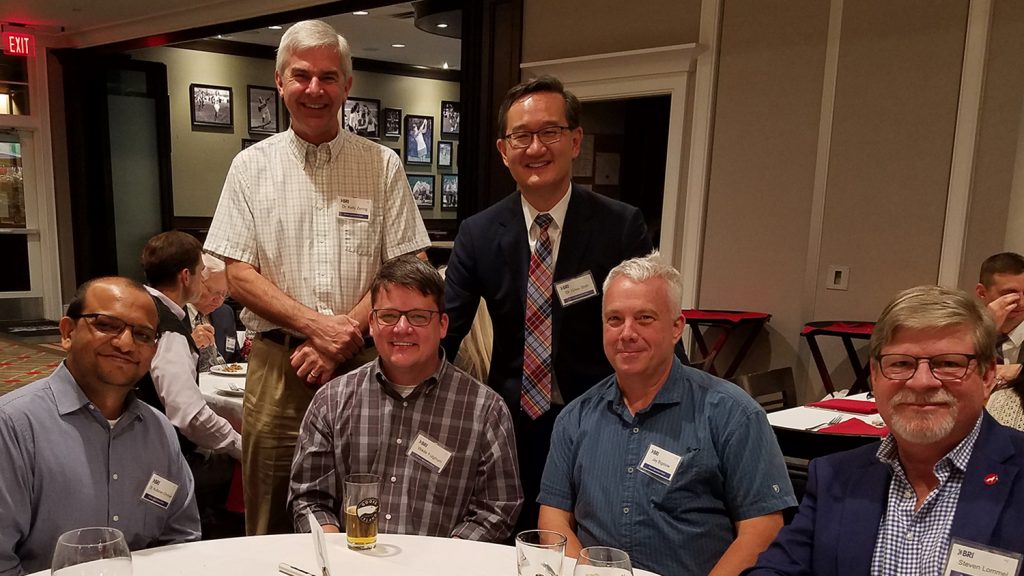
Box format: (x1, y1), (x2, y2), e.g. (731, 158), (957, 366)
(132, 48), (459, 218)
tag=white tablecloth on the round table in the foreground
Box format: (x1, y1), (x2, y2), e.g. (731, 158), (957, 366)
(34, 534), (654, 576)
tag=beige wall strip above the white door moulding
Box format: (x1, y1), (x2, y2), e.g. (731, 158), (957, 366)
(522, 0), (700, 61)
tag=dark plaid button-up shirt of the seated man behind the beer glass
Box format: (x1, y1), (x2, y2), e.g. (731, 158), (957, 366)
(289, 360), (522, 541)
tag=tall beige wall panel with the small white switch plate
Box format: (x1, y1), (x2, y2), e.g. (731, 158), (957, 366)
(814, 0), (968, 320)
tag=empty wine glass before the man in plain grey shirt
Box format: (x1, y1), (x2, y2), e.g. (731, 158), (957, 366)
(51, 528), (131, 576)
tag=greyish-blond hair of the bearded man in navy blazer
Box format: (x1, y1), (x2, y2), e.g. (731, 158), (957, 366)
(868, 286), (997, 370)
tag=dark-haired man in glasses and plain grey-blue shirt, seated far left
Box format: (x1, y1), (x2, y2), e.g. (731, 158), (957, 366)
(0, 278), (200, 576)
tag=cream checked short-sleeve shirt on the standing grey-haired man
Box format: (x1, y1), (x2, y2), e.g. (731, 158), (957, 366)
(205, 129), (430, 332)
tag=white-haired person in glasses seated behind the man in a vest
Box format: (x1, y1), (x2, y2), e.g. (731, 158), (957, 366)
(185, 254), (242, 372)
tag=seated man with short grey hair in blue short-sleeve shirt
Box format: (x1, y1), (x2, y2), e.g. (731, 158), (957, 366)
(538, 252), (797, 576)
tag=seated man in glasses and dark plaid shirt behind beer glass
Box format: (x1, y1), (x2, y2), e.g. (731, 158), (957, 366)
(290, 255), (522, 542)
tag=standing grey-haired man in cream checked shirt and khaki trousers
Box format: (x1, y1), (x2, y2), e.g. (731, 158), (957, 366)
(206, 22), (430, 534)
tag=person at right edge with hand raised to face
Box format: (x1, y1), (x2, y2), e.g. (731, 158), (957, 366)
(975, 252), (1024, 429)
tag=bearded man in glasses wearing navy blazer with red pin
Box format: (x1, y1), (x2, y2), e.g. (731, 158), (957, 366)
(750, 286), (1024, 576)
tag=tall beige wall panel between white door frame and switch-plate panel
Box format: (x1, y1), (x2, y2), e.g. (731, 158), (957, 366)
(698, 0), (828, 372)
